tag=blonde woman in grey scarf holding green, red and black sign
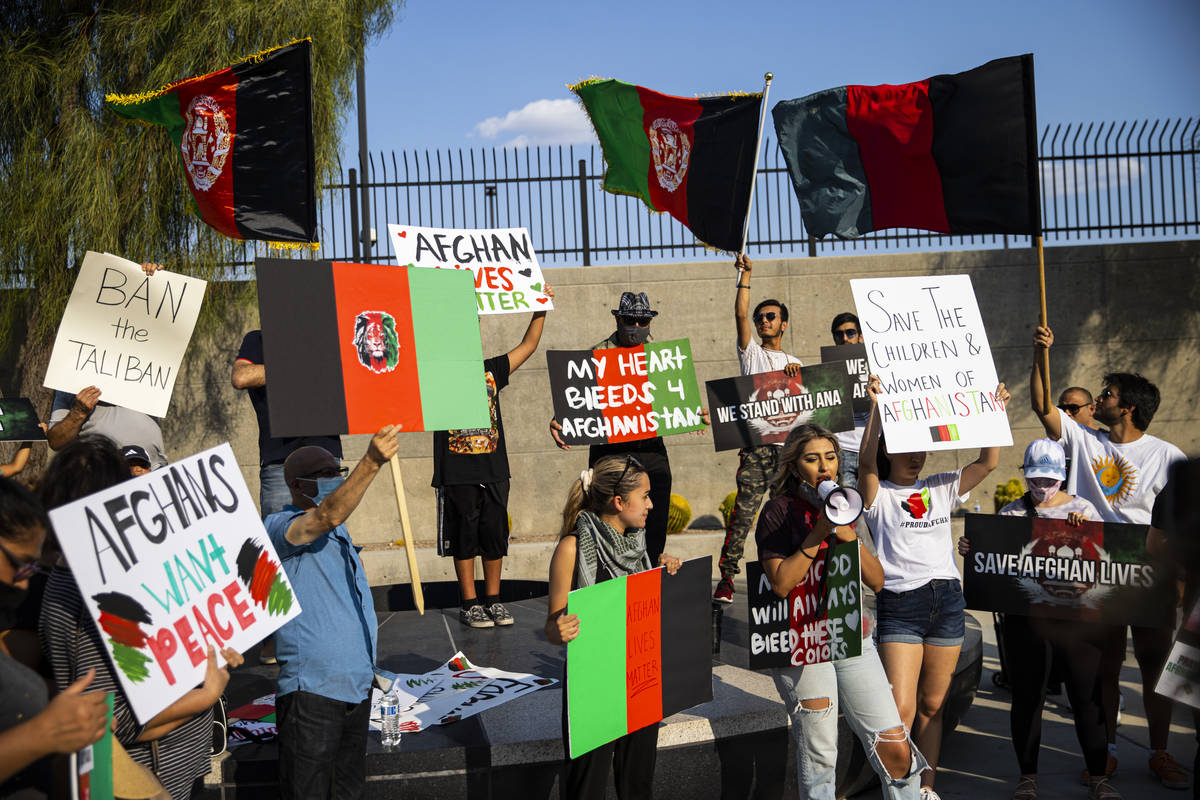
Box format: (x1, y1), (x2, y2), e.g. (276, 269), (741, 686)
(545, 456), (680, 800)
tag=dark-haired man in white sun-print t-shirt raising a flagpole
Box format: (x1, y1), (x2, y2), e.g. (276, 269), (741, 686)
(1030, 326), (1189, 789)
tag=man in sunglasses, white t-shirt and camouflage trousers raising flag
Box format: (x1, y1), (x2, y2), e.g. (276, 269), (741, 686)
(713, 253), (802, 603)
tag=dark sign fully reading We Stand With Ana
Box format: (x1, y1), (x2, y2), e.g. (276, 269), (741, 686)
(704, 363), (854, 450)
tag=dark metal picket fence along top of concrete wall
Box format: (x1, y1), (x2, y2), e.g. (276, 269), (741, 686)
(318, 118), (1200, 266)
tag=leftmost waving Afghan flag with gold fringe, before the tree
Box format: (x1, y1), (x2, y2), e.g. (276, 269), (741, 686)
(104, 40), (317, 242)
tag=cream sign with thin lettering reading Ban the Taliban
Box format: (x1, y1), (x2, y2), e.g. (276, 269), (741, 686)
(43, 251), (208, 416)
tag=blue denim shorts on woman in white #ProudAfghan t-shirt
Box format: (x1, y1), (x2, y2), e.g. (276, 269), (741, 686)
(876, 578), (967, 648)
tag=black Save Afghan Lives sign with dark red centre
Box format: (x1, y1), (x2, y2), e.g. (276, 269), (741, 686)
(962, 513), (1175, 627)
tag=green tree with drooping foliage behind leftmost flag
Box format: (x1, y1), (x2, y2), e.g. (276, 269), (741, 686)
(0, 0), (400, 467)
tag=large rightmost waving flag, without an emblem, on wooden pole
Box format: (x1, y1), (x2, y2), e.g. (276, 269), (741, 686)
(772, 54), (1042, 239)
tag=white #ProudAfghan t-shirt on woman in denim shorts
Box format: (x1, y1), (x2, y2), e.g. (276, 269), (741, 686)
(864, 470), (962, 591)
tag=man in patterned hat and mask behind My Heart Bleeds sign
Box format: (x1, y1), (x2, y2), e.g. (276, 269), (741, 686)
(550, 291), (671, 565)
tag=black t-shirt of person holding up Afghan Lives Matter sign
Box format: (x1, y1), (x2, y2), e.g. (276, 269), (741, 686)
(433, 354), (509, 486)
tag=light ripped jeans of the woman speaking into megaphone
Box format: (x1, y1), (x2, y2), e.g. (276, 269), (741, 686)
(773, 640), (929, 800)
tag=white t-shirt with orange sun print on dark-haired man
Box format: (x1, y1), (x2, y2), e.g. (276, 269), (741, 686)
(1055, 409), (1187, 525)
